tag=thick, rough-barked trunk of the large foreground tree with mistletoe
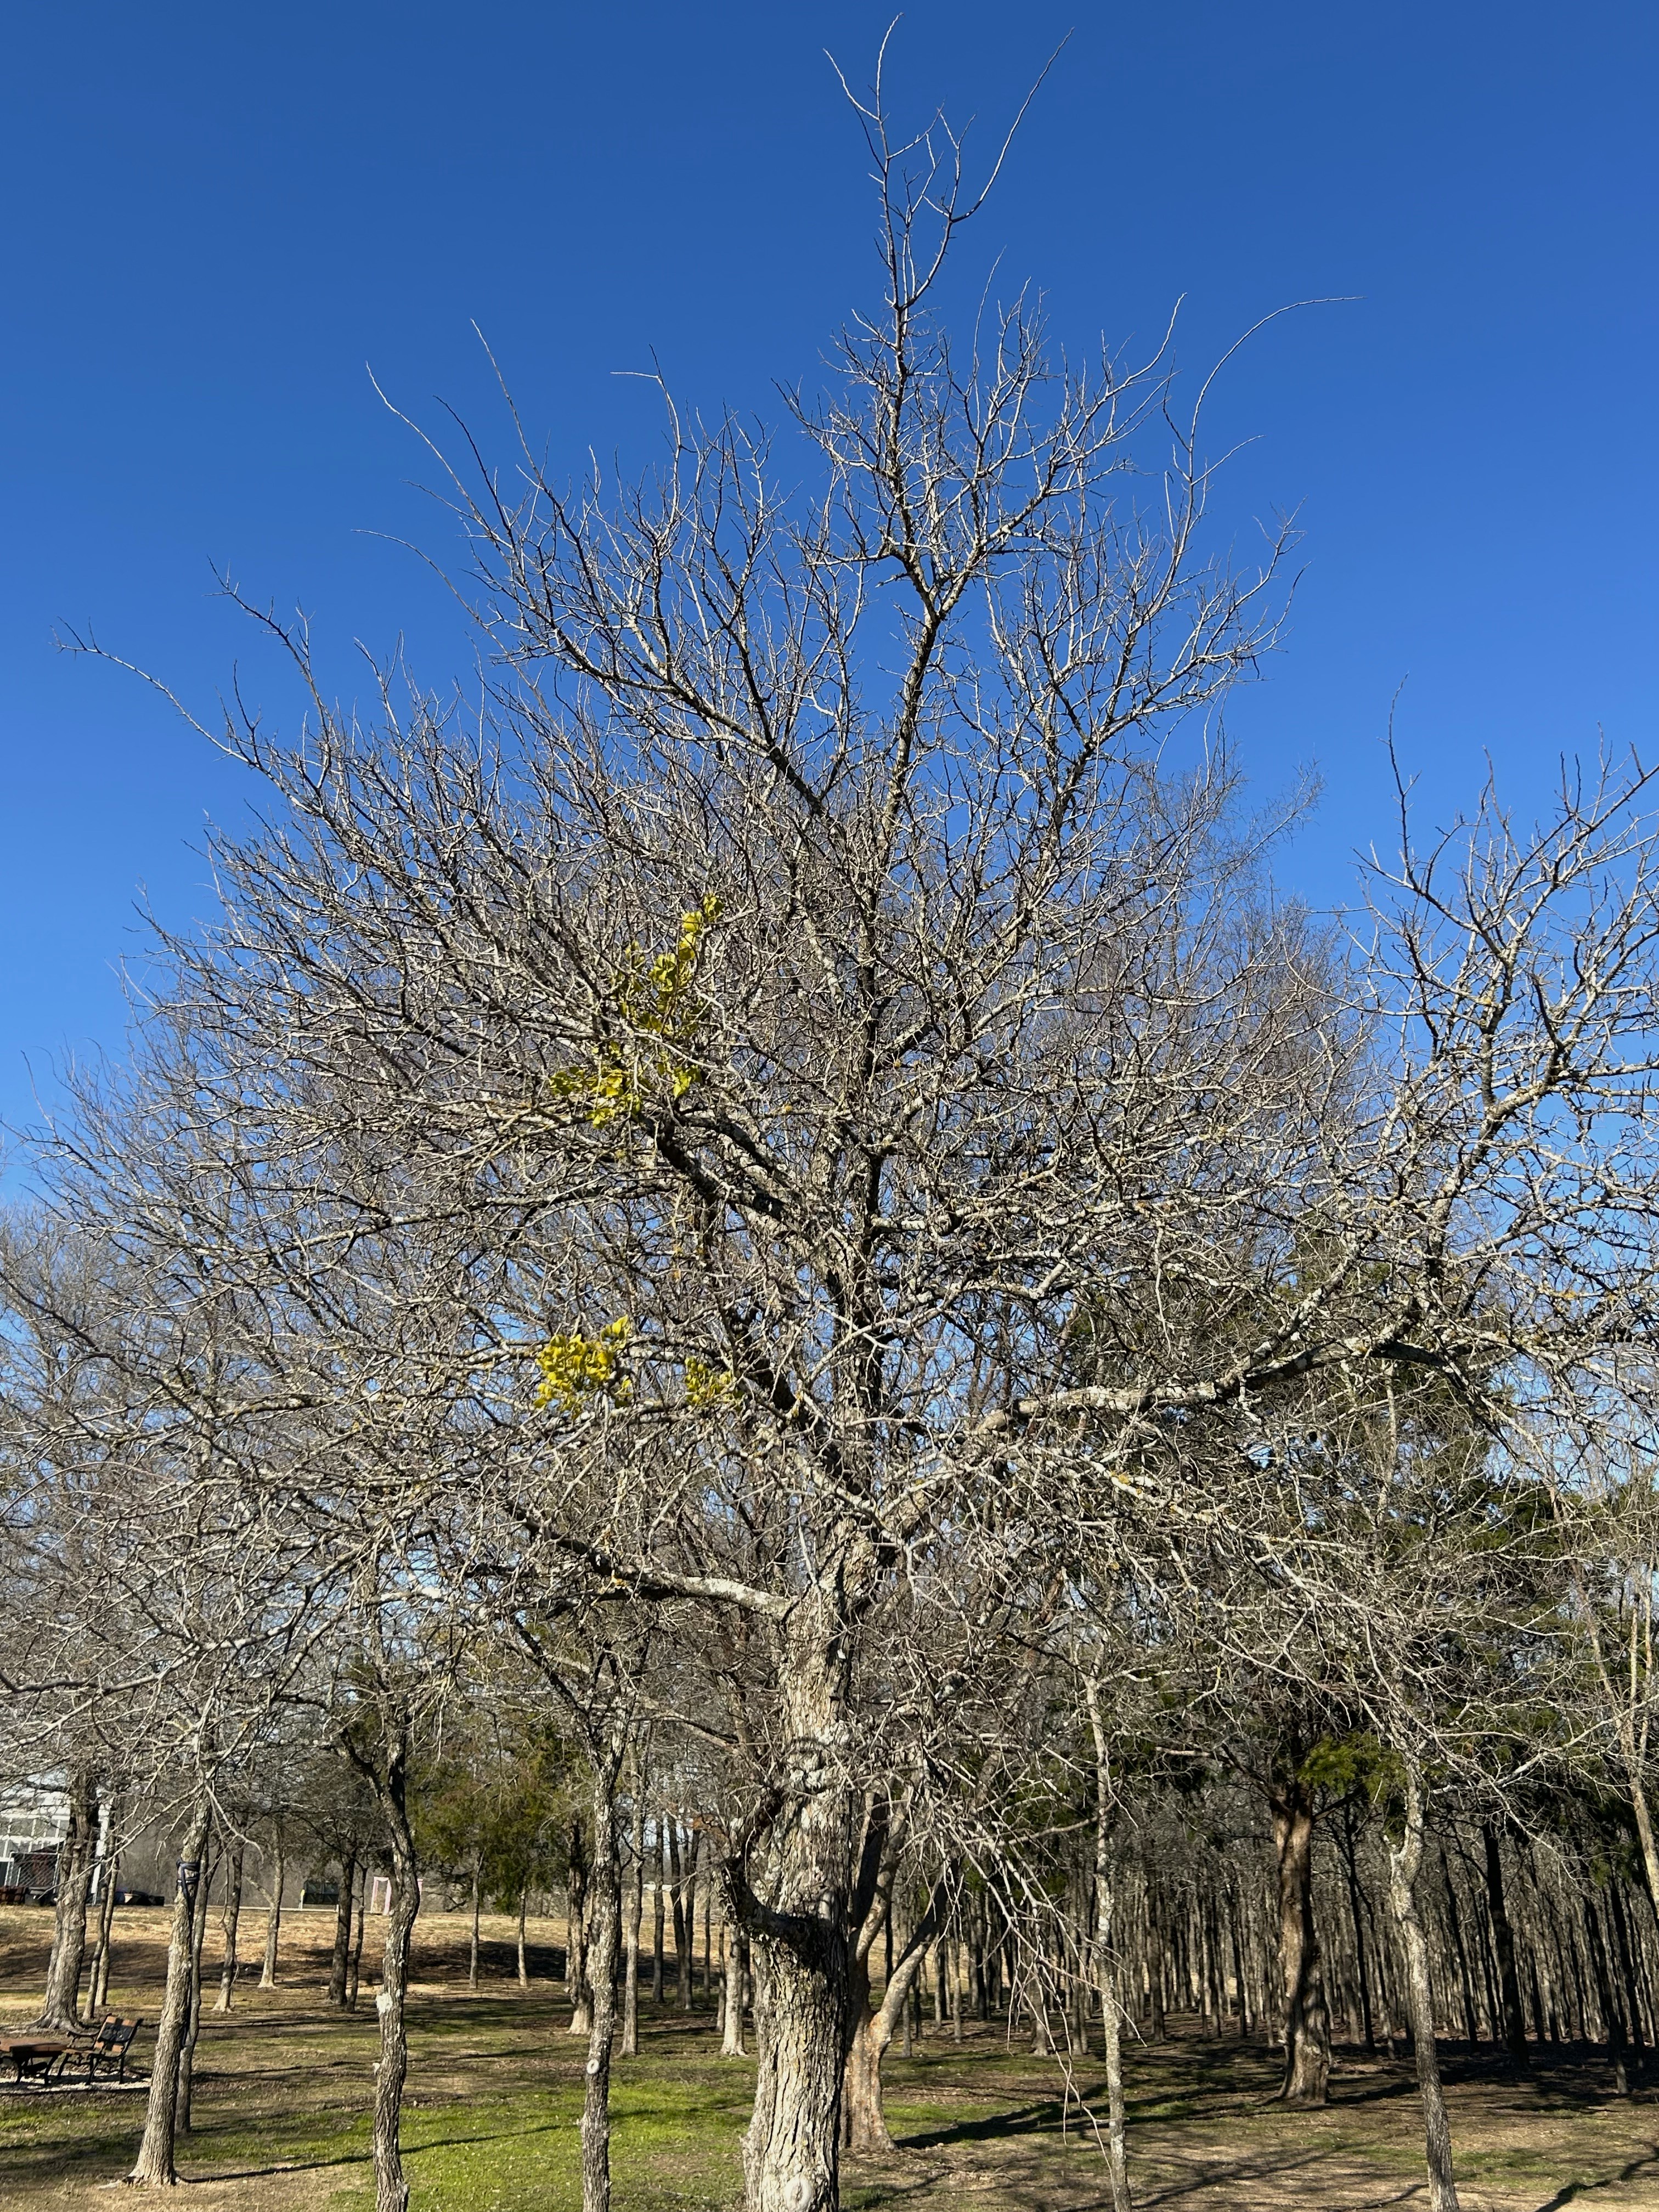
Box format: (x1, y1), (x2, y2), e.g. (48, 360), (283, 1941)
(728, 1628), (854, 2212)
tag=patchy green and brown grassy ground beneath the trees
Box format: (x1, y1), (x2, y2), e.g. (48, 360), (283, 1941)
(0, 1909), (1659, 2212)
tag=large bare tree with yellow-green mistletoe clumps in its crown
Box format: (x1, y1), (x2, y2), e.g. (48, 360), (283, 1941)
(48, 26), (1659, 2212)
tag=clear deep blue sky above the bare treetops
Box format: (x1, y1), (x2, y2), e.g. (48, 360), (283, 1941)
(0, 0), (1659, 1119)
